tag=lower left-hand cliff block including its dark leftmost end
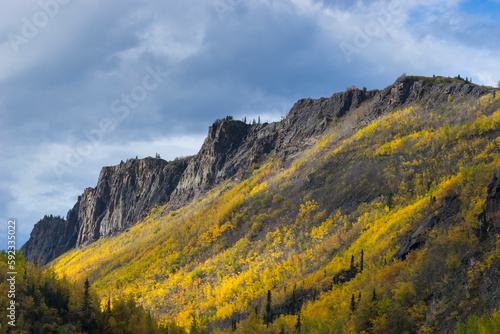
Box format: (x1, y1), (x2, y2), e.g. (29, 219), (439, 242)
(23, 158), (189, 264)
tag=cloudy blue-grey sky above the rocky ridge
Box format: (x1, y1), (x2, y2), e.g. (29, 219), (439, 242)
(0, 0), (500, 249)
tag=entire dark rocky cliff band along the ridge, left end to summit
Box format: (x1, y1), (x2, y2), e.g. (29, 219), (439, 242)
(23, 77), (490, 263)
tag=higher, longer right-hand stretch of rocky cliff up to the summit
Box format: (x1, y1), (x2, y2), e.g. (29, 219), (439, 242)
(169, 77), (488, 209)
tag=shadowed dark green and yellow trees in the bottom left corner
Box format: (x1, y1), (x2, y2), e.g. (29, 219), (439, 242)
(0, 251), (180, 334)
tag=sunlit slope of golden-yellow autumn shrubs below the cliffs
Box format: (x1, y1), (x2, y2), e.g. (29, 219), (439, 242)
(53, 92), (500, 333)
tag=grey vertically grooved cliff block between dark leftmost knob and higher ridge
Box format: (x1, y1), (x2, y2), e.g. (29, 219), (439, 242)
(73, 158), (190, 247)
